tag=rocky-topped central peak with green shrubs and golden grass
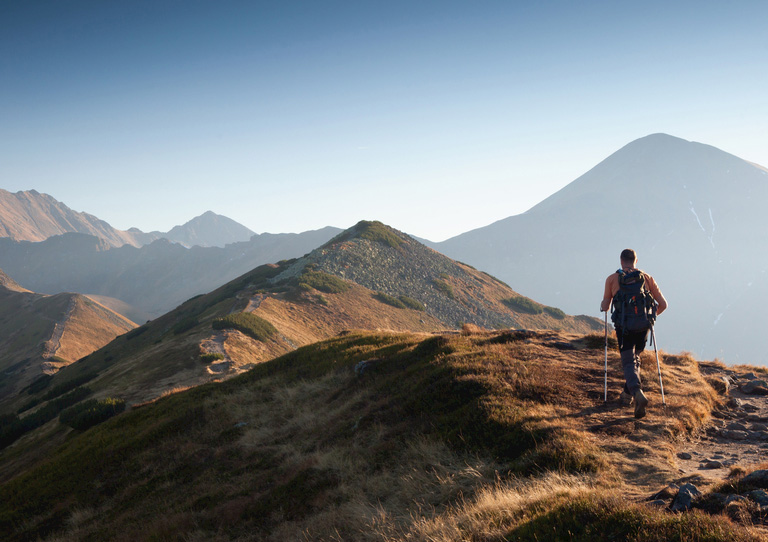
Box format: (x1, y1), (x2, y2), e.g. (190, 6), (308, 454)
(0, 222), (601, 412)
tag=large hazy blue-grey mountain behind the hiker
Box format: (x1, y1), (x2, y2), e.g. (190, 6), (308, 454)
(433, 134), (768, 364)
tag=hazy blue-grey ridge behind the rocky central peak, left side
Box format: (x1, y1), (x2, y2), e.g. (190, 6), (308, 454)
(0, 227), (341, 321)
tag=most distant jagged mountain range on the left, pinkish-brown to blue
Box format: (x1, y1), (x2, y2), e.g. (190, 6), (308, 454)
(0, 189), (254, 247)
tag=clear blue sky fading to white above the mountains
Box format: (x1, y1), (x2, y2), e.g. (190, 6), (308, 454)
(0, 0), (768, 241)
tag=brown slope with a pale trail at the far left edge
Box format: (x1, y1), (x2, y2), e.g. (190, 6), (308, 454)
(0, 271), (136, 404)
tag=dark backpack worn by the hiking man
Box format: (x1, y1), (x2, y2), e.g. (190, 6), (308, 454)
(611, 269), (656, 332)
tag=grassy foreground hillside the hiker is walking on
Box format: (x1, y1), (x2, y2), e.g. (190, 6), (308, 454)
(0, 331), (766, 542)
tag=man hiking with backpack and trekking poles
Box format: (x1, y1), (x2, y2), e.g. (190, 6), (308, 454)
(600, 248), (667, 418)
